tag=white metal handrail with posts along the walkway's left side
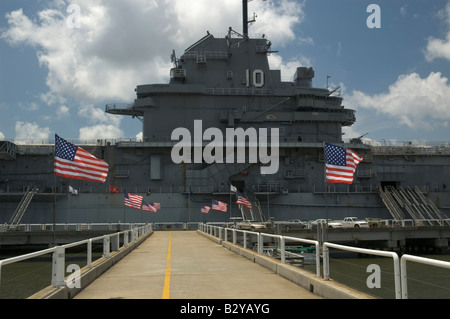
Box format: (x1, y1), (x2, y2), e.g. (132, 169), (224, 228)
(0, 224), (153, 287)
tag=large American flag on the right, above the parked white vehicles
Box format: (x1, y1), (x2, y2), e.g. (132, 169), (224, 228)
(325, 143), (363, 184)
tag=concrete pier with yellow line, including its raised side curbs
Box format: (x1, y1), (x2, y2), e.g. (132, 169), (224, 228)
(30, 230), (371, 299)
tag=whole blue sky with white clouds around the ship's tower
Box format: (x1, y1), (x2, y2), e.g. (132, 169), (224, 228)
(0, 0), (450, 143)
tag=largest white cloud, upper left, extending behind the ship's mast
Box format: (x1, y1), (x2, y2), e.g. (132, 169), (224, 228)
(0, 0), (303, 138)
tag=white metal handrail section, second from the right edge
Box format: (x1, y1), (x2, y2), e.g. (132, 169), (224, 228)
(323, 242), (402, 299)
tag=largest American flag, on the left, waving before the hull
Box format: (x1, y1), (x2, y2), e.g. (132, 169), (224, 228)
(53, 134), (109, 183)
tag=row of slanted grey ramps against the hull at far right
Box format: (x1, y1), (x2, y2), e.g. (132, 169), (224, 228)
(379, 186), (450, 226)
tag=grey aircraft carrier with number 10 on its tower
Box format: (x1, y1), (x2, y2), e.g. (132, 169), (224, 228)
(0, 0), (450, 225)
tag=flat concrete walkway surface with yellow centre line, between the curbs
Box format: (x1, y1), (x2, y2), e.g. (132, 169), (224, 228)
(75, 231), (321, 299)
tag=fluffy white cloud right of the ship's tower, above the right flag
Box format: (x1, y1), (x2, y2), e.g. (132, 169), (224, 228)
(344, 72), (450, 131)
